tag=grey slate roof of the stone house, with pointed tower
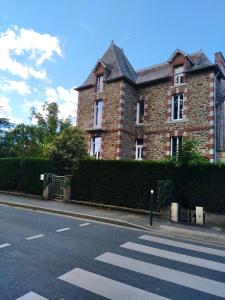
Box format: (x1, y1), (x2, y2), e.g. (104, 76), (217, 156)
(77, 42), (214, 90)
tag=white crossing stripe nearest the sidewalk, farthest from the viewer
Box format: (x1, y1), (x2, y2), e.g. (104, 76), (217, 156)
(139, 235), (225, 257)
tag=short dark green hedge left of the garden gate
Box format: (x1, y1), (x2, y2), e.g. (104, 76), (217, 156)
(0, 158), (53, 195)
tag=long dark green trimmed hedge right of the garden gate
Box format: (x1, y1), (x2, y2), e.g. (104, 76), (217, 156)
(72, 160), (225, 213)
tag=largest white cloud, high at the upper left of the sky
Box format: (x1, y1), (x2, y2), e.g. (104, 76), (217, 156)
(0, 26), (62, 79)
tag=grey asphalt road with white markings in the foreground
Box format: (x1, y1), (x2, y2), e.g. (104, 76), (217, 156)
(0, 205), (225, 300)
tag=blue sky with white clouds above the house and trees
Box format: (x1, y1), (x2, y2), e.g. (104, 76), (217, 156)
(0, 0), (225, 124)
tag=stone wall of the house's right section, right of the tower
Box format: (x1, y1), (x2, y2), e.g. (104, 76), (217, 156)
(140, 71), (213, 159)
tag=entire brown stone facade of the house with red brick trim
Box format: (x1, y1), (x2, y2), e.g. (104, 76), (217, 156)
(78, 71), (214, 160)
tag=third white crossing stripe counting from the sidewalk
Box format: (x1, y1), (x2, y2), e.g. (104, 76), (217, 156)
(95, 252), (225, 298)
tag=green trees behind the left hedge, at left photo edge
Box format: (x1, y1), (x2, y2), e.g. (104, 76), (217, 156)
(0, 102), (71, 157)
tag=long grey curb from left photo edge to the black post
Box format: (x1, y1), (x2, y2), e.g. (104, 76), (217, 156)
(0, 201), (151, 231)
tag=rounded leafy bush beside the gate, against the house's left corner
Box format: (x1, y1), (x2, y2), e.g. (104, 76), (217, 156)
(45, 126), (88, 173)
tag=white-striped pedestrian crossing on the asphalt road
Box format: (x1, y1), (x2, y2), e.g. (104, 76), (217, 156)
(16, 235), (225, 300)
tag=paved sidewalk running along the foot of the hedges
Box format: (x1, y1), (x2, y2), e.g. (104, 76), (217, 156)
(0, 193), (225, 246)
